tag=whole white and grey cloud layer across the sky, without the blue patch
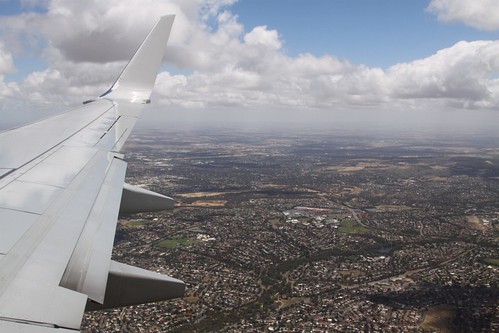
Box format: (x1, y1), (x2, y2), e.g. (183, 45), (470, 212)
(0, 0), (499, 120)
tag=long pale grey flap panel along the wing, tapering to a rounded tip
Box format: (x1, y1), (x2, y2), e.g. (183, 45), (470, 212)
(0, 151), (116, 328)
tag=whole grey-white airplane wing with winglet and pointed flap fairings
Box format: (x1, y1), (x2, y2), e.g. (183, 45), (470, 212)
(0, 16), (185, 332)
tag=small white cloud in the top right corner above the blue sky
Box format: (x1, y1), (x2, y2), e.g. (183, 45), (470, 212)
(428, 0), (499, 31)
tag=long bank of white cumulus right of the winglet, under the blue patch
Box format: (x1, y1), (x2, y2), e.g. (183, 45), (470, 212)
(157, 37), (499, 108)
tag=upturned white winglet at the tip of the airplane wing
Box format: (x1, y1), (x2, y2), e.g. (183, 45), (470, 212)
(100, 15), (175, 103)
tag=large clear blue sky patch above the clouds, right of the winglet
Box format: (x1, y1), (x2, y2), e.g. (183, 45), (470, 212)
(231, 0), (499, 68)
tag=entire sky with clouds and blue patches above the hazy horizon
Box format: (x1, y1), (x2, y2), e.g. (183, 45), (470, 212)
(0, 0), (499, 132)
